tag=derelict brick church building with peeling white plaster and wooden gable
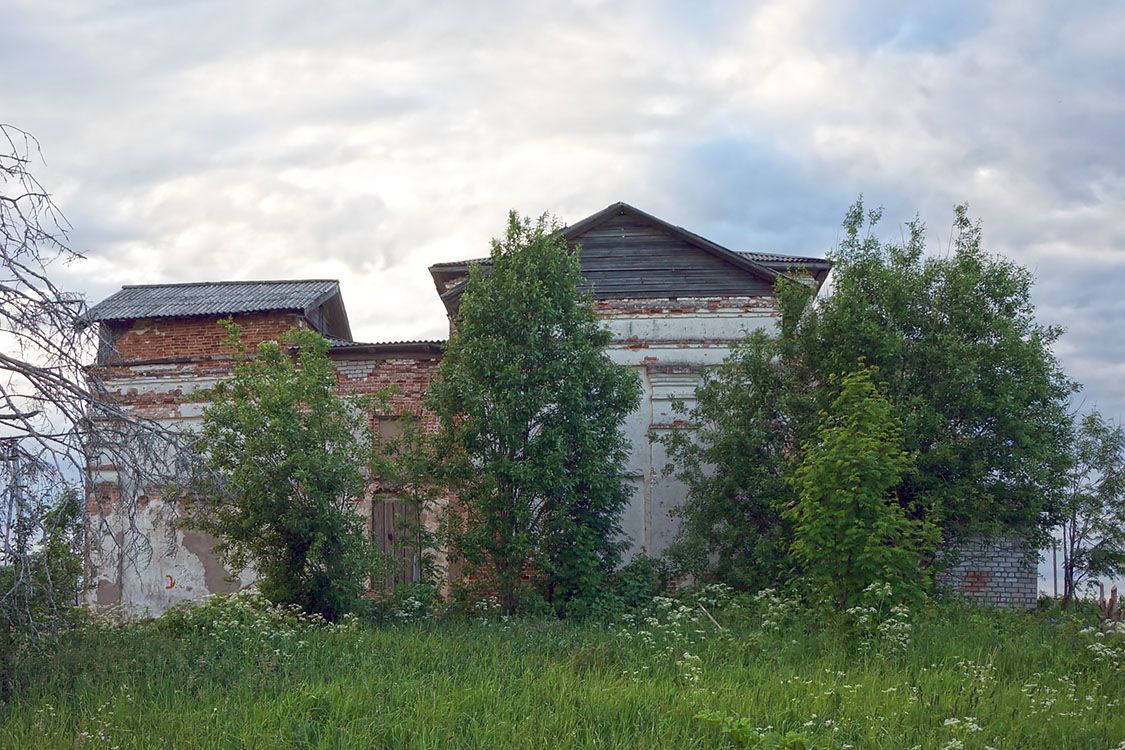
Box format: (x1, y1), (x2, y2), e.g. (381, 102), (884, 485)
(87, 204), (1037, 614)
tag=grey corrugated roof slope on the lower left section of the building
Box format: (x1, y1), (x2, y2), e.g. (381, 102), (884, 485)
(86, 279), (340, 323)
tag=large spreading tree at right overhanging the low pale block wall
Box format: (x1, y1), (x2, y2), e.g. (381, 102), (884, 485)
(783, 202), (1076, 545)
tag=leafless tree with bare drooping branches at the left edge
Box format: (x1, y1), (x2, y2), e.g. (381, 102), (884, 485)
(0, 124), (193, 631)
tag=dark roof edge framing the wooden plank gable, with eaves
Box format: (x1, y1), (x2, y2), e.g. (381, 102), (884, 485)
(430, 201), (831, 306)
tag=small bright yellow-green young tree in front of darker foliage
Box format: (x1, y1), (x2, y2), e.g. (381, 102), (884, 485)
(784, 368), (937, 609)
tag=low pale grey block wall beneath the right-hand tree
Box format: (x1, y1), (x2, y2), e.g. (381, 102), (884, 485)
(937, 537), (1038, 609)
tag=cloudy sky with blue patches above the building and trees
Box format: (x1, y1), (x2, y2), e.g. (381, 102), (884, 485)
(0, 0), (1125, 418)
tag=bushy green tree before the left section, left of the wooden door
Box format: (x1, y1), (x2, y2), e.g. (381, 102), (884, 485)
(190, 320), (376, 620)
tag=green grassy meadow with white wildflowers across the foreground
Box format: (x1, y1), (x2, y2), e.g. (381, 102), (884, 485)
(0, 590), (1125, 750)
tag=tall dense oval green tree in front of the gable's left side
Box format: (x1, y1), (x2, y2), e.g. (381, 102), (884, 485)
(429, 213), (639, 613)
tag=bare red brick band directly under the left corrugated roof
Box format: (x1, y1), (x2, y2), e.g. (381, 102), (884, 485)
(104, 313), (308, 364)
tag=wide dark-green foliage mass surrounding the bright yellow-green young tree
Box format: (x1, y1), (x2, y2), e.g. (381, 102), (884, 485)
(668, 201), (1074, 587)
